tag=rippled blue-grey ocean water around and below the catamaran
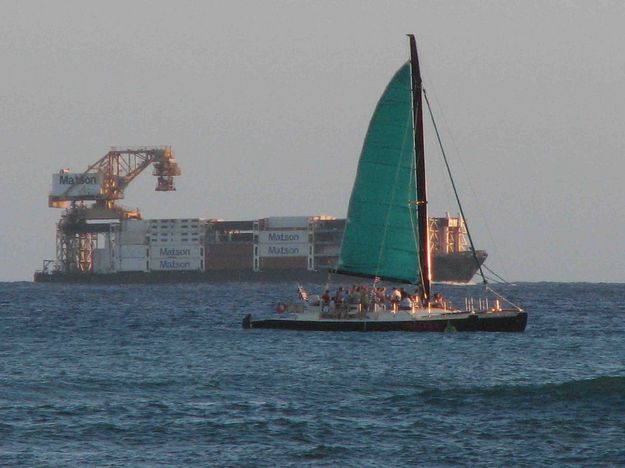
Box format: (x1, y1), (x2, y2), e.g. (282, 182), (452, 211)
(0, 283), (625, 467)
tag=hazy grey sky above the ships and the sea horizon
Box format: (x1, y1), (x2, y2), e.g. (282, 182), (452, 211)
(0, 0), (625, 282)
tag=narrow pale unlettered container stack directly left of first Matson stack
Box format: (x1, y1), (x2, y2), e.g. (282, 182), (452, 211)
(117, 219), (149, 271)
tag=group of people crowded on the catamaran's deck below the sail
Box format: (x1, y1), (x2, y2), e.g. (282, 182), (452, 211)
(320, 285), (447, 312)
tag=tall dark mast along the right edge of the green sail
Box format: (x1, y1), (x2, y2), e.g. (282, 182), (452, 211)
(408, 34), (431, 300)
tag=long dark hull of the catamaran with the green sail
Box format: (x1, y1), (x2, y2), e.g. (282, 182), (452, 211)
(242, 312), (527, 332)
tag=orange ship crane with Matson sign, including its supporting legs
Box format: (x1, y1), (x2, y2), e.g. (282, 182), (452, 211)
(48, 146), (182, 273)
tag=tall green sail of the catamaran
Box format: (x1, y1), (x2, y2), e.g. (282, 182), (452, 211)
(337, 63), (420, 284)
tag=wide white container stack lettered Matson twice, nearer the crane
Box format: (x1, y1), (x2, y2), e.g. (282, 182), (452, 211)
(148, 218), (205, 271)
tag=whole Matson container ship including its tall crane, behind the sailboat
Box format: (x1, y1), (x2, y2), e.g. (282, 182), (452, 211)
(34, 147), (487, 283)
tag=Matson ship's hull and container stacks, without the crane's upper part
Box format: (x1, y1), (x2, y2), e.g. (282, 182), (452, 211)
(35, 214), (486, 283)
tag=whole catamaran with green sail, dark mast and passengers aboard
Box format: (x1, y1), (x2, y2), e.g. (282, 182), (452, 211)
(242, 35), (527, 332)
